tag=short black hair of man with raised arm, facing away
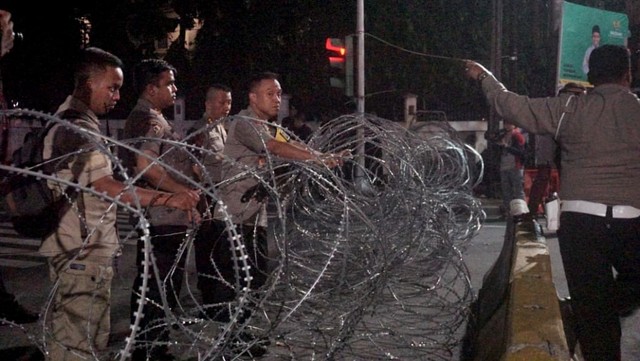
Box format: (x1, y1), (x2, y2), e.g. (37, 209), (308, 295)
(587, 44), (631, 85)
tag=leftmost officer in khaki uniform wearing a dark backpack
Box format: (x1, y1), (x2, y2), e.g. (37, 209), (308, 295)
(40, 48), (199, 361)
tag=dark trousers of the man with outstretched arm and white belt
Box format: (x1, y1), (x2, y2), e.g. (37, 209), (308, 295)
(558, 211), (640, 360)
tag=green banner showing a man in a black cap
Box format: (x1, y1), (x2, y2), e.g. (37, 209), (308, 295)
(558, 1), (629, 86)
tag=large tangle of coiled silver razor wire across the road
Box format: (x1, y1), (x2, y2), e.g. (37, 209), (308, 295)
(0, 110), (484, 360)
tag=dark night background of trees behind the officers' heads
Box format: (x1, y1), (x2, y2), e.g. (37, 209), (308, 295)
(0, 0), (631, 120)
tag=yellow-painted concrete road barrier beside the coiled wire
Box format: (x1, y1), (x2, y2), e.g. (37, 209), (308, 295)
(461, 220), (575, 361)
